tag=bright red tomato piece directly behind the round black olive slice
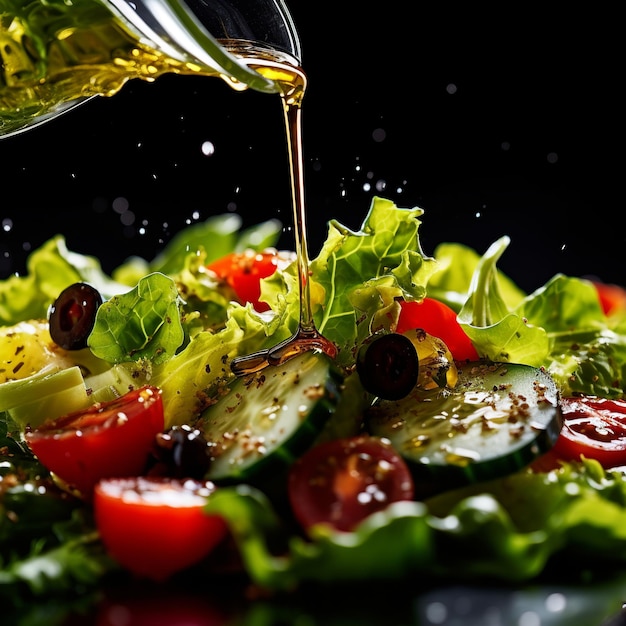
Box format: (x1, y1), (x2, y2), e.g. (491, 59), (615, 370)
(396, 298), (478, 361)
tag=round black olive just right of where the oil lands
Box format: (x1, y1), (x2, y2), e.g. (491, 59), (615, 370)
(356, 333), (419, 400)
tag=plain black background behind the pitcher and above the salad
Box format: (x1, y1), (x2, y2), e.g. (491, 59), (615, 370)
(0, 0), (626, 291)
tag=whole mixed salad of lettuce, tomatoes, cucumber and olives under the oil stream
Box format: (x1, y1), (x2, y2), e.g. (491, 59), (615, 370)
(0, 197), (626, 623)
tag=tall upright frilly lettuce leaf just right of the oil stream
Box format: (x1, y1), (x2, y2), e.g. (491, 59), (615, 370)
(311, 197), (436, 361)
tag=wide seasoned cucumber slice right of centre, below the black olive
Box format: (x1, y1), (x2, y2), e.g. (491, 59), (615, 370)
(366, 361), (563, 491)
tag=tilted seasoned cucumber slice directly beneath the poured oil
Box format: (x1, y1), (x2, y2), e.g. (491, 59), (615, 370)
(202, 352), (343, 484)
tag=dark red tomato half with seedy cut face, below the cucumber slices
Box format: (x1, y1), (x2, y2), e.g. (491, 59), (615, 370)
(288, 435), (414, 531)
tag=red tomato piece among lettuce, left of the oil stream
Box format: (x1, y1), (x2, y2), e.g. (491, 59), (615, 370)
(207, 250), (295, 312)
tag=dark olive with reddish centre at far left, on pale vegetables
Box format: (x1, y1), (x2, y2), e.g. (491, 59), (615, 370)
(48, 283), (102, 350)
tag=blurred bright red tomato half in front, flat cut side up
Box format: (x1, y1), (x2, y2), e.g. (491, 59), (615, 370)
(93, 477), (228, 582)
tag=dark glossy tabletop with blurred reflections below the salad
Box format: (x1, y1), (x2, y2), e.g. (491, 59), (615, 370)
(49, 575), (626, 626)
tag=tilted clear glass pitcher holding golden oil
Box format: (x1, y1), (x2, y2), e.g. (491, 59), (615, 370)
(0, 0), (301, 138)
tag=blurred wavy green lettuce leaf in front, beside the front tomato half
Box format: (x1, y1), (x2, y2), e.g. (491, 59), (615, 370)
(205, 485), (432, 591)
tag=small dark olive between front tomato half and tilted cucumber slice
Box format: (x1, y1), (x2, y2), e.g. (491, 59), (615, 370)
(154, 424), (211, 480)
